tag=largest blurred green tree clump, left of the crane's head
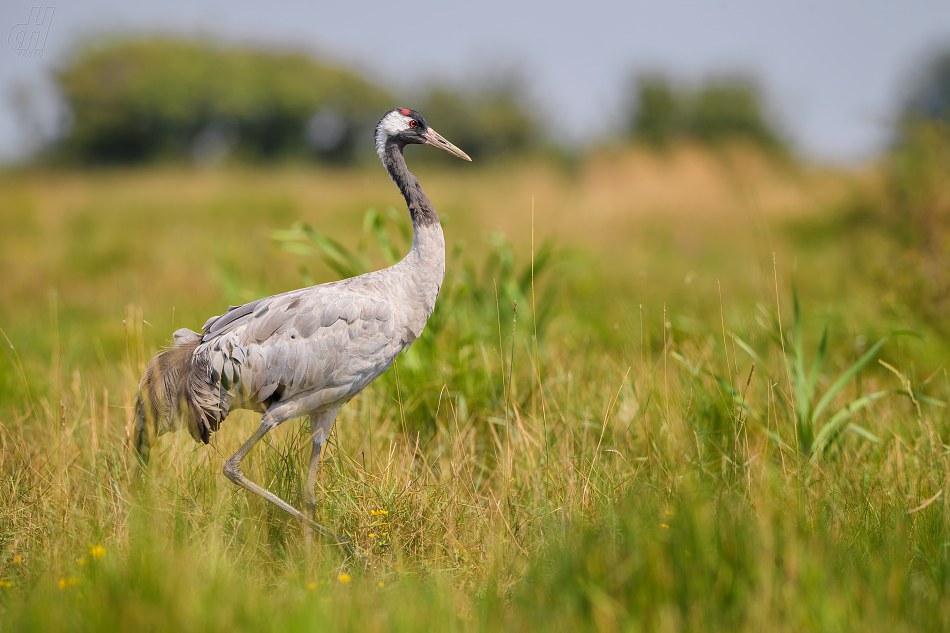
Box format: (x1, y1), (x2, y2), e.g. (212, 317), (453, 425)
(56, 39), (389, 163)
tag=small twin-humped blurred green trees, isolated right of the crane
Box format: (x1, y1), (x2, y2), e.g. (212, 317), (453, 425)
(627, 75), (785, 151)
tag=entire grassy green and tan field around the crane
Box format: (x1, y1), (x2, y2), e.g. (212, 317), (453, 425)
(0, 147), (950, 632)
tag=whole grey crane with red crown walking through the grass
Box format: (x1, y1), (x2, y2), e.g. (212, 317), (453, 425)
(132, 108), (471, 551)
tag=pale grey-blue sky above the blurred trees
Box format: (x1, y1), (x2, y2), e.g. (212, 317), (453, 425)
(0, 0), (950, 163)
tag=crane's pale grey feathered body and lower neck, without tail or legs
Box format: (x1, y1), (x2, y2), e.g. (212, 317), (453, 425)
(194, 224), (445, 426)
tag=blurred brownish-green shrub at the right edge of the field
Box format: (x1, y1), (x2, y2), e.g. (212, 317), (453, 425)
(816, 47), (950, 335)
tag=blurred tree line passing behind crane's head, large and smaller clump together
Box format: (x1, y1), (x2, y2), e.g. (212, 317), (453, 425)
(53, 39), (542, 164)
